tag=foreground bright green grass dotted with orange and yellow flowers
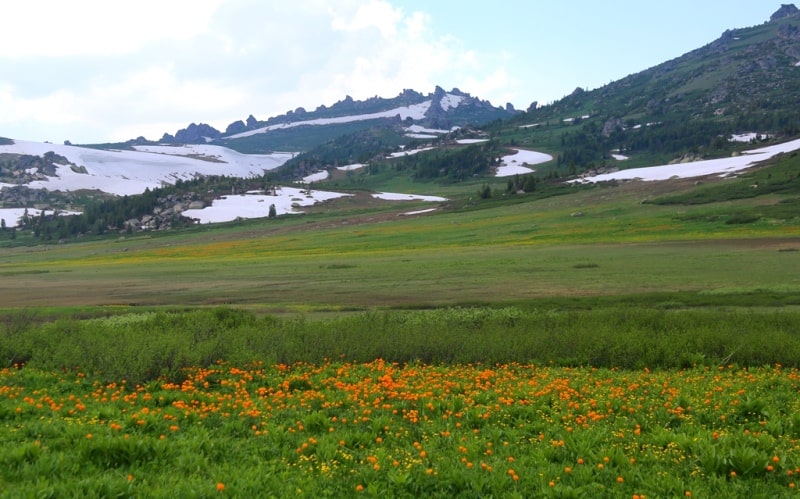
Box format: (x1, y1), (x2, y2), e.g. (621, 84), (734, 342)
(0, 360), (800, 497)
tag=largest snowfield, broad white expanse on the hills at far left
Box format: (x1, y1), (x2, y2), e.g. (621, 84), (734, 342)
(0, 141), (292, 195)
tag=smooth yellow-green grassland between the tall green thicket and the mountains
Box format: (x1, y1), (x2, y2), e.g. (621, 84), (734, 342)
(0, 172), (800, 310)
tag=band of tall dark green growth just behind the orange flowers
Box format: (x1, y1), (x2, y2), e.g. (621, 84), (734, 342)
(6, 306), (800, 382)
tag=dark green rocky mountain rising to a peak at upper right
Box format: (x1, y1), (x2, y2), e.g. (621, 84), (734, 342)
(493, 4), (800, 172)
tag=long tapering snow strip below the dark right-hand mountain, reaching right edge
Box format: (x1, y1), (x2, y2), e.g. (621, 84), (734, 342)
(570, 139), (800, 183)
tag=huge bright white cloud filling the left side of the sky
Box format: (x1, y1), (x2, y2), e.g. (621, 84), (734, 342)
(0, 0), (514, 143)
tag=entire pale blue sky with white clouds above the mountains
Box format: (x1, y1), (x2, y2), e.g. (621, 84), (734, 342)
(0, 0), (786, 144)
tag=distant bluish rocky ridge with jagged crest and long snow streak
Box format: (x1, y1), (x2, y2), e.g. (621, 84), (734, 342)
(159, 86), (518, 153)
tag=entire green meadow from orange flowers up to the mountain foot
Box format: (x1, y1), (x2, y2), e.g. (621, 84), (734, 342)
(0, 157), (800, 498)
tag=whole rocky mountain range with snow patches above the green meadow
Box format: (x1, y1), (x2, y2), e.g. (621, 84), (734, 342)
(0, 4), (800, 238)
